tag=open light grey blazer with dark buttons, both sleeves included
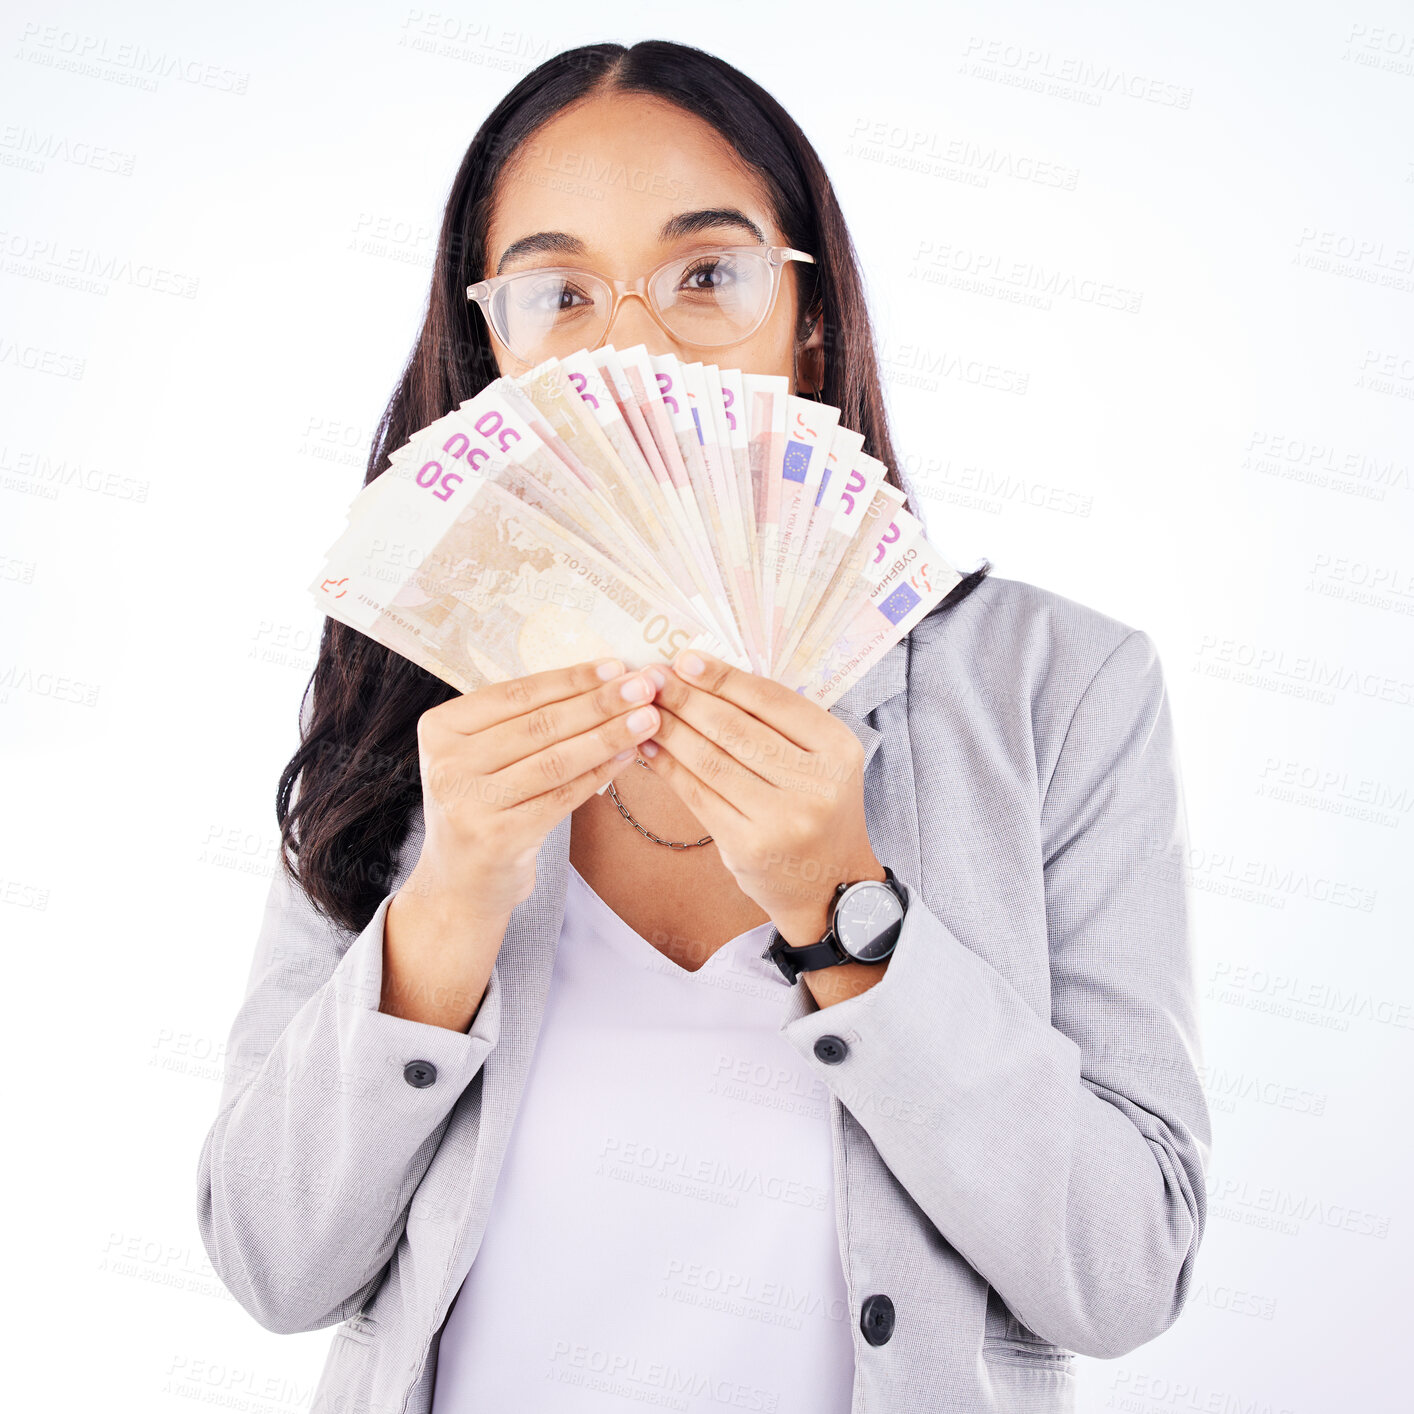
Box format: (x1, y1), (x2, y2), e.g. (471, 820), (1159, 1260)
(198, 577), (1210, 1414)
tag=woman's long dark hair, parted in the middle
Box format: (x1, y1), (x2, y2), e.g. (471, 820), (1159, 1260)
(276, 40), (991, 932)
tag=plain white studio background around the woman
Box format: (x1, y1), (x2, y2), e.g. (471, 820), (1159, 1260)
(0, 0), (1414, 1414)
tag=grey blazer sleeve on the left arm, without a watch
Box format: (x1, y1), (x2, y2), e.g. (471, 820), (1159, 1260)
(197, 848), (501, 1333)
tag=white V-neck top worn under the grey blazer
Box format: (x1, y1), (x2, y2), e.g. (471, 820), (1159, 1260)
(433, 865), (854, 1414)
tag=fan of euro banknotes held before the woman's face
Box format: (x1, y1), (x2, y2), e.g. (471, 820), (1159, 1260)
(310, 345), (960, 707)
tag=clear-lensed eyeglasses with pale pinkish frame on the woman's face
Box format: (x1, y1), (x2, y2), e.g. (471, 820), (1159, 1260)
(467, 246), (814, 363)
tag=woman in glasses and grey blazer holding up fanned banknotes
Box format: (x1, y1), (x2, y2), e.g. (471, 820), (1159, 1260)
(199, 42), (1209, 1414)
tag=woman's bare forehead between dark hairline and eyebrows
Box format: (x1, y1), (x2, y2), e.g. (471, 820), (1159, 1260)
(485, 93), (782, 274)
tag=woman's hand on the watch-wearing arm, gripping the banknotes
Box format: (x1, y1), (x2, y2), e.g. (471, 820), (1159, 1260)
(639, 649), (884, 947)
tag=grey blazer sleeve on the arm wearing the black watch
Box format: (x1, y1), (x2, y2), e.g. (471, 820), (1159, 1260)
(782, 629), (1212, 1359)
